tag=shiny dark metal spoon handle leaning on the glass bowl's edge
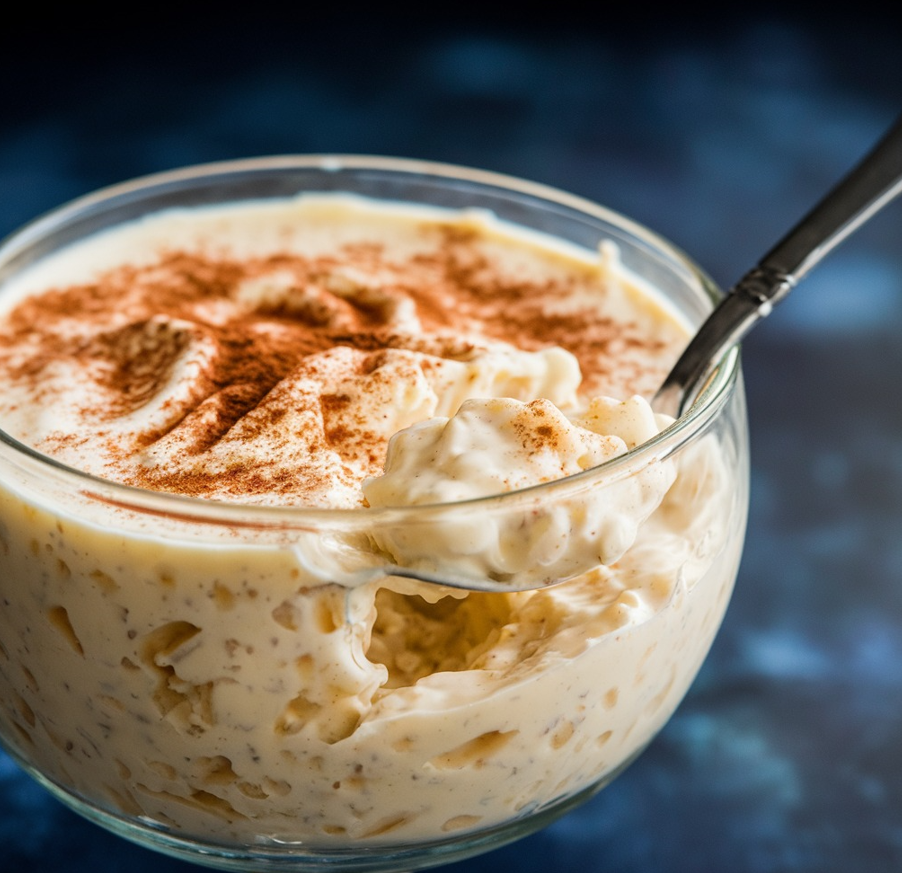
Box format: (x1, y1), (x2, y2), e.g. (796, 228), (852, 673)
(651, 113), (902, 418)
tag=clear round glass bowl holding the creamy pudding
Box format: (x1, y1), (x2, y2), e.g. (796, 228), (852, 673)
(0, 156), (748, 871)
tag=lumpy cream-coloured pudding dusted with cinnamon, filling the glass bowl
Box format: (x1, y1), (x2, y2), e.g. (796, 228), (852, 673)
(0, 197), (745, 846)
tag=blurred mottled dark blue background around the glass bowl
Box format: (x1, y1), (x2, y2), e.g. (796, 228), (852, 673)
(0, 13), (902, 873)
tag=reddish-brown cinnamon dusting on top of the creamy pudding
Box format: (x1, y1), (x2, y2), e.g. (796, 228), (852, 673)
(0, 217), (672, 504)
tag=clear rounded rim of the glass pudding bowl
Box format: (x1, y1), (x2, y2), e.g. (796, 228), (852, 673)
(0, 154), (739, 530)
